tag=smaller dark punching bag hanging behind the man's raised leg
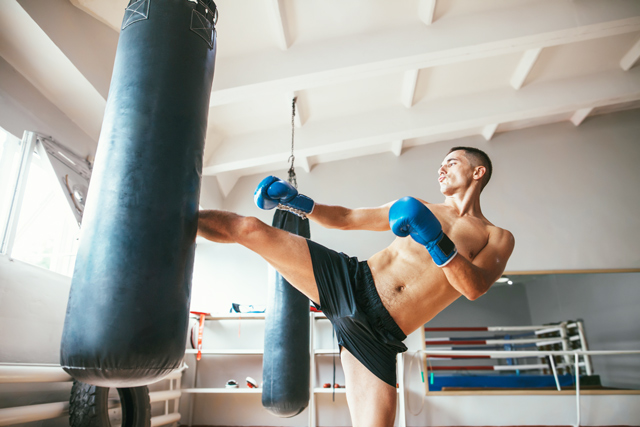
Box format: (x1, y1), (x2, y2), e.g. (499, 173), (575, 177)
(262, 210), (311, 417)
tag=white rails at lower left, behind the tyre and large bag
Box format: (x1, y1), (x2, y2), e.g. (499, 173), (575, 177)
(0, 364), (186, 427)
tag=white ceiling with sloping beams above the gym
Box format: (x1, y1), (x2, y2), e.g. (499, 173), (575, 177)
(0, 0), (640, 195)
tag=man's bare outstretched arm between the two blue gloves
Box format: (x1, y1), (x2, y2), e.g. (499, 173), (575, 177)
(308, 203), (391, 231)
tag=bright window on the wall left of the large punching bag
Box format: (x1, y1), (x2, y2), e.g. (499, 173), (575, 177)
(0, 132), (88, 276)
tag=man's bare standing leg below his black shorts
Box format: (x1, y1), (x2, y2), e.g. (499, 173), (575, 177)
(340, 348), (397, 427)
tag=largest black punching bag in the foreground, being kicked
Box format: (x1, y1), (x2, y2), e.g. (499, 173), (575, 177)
(60, 0), (217, 387)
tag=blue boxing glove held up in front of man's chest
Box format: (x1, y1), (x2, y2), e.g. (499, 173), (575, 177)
(389, 197), (458, 267)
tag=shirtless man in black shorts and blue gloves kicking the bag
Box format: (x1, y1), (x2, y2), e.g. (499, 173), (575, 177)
(198, 147), (514, 427)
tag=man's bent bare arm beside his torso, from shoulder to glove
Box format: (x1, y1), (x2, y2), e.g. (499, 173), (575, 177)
(442, 228), (515, 301)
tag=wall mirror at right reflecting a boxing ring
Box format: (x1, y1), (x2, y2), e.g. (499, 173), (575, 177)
(425, 271), (640, 391)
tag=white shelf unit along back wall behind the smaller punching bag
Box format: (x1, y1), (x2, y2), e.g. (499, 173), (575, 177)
(181, 312), (406, 427)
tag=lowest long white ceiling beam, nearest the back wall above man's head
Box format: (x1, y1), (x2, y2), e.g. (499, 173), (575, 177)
(203, 69), (640, 181)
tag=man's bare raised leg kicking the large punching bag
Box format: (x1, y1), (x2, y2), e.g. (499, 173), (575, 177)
(198, 210), (320, 303)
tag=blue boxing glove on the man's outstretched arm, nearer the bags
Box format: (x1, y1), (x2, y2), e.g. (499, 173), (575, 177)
(253, 176), (315, 218)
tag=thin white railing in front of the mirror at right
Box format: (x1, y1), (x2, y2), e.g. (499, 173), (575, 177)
(418, 350), (640, 427)
